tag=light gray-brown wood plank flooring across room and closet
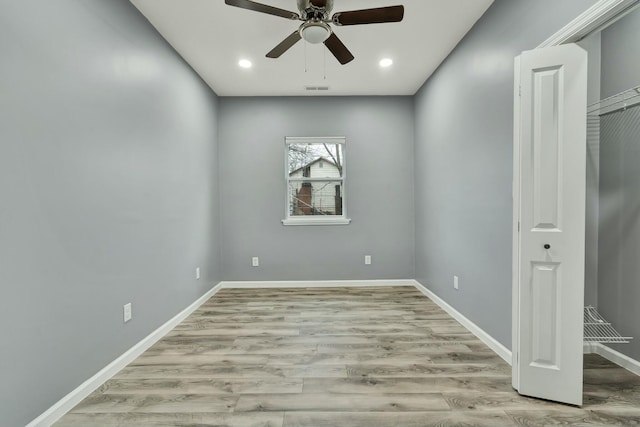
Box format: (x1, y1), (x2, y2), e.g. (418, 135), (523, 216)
(56, 287), (640, 427)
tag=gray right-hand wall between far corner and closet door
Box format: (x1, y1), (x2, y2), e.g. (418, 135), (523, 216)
(415, 0), (594, 347)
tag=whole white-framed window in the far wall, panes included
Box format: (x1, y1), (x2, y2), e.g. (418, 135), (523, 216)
(282, 137), (351, 225)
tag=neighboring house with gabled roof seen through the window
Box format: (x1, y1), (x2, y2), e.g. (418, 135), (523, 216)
(289, 157), (342, 215)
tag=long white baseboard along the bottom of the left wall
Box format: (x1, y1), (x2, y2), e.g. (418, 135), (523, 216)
(26, 283), (222, 427)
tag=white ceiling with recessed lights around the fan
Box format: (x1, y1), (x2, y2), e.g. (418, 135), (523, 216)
(131, 0), (493, 96)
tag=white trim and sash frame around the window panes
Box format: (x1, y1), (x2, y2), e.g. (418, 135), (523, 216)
(282, 136), (351, 226)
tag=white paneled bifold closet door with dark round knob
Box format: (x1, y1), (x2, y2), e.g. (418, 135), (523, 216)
(513, 44), (587, 405)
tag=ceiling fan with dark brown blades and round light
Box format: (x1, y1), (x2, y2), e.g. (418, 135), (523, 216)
(225, 0), (404, 65)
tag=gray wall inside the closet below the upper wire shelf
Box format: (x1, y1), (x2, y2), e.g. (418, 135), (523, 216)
(598, 106), (640, 360)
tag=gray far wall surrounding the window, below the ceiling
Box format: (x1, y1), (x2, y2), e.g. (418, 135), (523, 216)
(219, 97), (414, 280)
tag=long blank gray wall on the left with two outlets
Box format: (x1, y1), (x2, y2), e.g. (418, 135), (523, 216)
(0, 0), (220, 427)
